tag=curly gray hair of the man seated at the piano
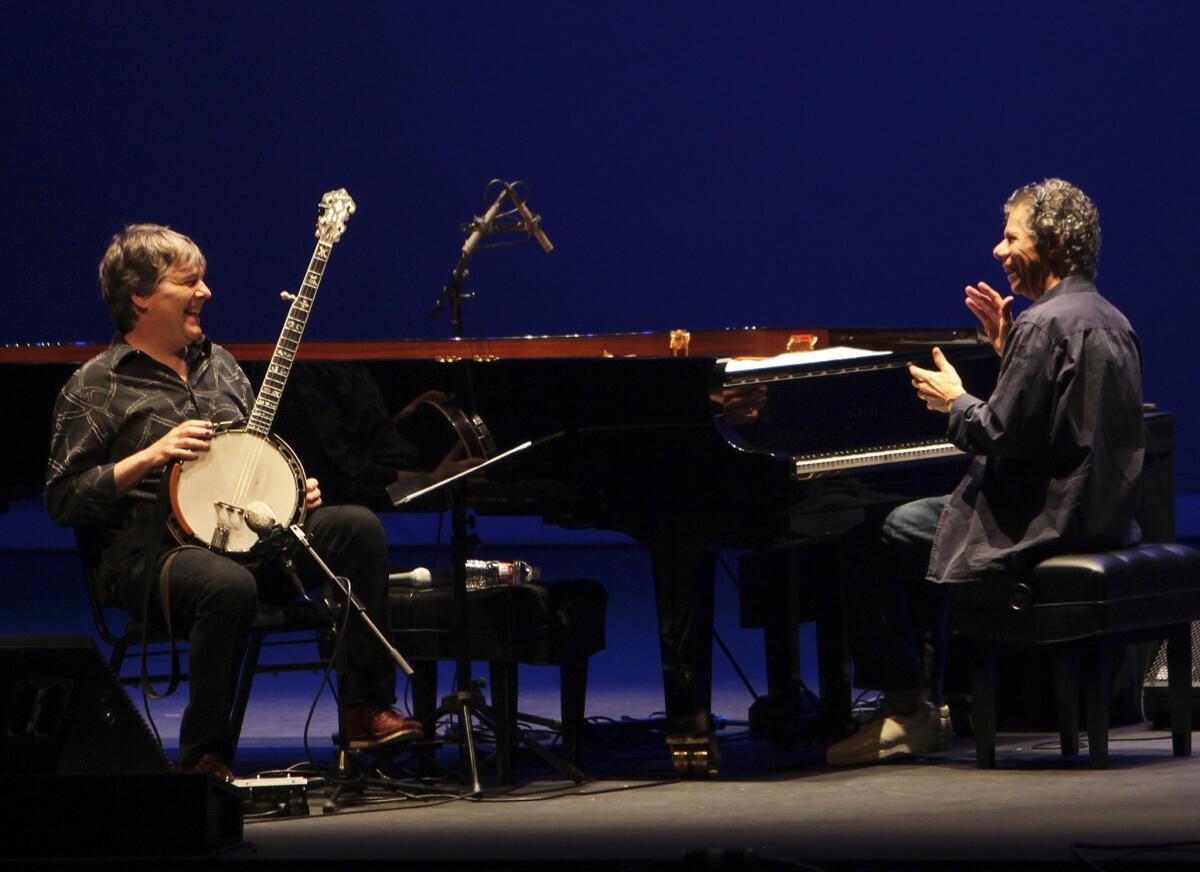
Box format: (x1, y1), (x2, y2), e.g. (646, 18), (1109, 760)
(1004, 179), (1100, 279)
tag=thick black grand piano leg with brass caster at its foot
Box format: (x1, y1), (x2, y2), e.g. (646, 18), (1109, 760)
(635, 518), (720, 777)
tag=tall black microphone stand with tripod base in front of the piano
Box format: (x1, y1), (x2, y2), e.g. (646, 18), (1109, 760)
(431, 180), (583, 794)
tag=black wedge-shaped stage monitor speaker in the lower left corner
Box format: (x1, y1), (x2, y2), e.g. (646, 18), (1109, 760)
(0, 636), (172, 775)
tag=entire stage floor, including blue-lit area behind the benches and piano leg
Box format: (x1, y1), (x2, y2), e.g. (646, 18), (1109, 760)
(0, 534), (1200, 872)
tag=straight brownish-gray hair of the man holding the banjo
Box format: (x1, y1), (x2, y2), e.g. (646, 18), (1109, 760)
(100, 224), (206, 336)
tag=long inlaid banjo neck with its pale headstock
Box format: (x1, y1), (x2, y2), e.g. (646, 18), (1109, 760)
(246, 188), (355, 437)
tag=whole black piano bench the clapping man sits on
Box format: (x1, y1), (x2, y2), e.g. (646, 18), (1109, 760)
(950, 545), (1200, 769)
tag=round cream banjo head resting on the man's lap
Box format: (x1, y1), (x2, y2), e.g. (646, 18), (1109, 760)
(170, 429), (305, 554)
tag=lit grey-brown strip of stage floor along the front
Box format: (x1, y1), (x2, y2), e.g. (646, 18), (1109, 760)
(216, 727), (1200, 870)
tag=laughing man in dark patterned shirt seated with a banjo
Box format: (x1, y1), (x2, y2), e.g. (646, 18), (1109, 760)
(46, 224), (464, 780)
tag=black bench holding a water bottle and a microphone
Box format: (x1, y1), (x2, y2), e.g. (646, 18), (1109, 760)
(388, 578), (608, 783)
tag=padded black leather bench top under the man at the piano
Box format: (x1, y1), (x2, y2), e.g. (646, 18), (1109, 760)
(950, 543), (1200, 645)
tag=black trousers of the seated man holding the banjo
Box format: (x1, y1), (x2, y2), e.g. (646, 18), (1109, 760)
(129, 506), (396, 763)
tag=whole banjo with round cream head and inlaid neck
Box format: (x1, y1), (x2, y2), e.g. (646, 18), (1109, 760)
(167, 188), (355, 557)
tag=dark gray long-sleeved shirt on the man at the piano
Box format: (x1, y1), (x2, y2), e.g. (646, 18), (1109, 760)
(928, 276), (1145, 582)
